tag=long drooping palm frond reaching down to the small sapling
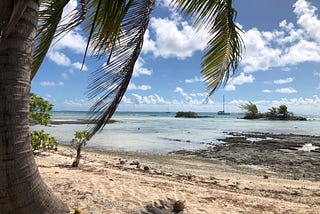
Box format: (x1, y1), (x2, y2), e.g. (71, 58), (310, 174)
(88, 0), (154, 134)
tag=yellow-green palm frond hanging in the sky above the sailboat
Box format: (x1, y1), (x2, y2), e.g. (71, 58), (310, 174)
(172, 0), (243, 95)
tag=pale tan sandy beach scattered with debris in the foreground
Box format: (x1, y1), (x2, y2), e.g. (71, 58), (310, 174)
(35, 133), (320, 214)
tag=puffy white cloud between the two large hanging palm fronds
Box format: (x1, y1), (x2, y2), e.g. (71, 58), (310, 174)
(142, 17), (208, 59)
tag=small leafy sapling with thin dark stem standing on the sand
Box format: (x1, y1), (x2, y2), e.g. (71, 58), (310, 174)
(70, 131), (92, 167)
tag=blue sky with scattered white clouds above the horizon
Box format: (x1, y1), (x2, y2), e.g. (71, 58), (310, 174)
(31, 0), (320, 115)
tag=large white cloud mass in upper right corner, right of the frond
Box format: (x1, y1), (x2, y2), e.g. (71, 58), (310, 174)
(241, 0), (320, 72)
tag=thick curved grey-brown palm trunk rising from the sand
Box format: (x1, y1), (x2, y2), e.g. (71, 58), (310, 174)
(0, 0), (69, 214)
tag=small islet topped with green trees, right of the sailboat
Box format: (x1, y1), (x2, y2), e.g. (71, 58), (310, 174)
(240, 102), (306, 120)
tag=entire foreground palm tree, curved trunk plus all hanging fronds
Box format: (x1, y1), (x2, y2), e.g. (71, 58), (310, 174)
(0, 0), (242, 214)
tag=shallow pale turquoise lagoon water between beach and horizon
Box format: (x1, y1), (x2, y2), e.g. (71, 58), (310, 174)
(30, 111), (320, 153)
